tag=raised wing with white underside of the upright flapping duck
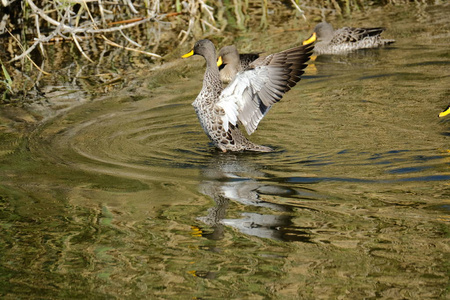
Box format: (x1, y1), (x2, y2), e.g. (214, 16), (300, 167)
(216, 45), (314, 134)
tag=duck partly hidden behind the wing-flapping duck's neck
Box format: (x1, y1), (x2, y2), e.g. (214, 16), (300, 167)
(218, 45), (259, 83)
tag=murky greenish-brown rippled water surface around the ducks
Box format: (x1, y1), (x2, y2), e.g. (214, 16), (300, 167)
(0, 5), (450, 299)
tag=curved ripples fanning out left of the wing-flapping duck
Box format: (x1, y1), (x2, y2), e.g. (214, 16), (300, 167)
(31, 95), (218, 179)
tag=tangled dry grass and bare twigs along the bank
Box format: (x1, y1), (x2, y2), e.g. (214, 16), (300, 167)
(0, 0), (440, 101)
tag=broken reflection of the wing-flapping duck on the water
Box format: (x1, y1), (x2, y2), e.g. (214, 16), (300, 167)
(193, 153), (316, 242)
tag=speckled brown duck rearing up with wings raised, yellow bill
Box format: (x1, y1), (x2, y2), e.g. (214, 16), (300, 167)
(182, 39), (314, 152)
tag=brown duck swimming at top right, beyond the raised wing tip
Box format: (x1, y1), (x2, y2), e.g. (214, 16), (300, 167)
(303, 22), (395, 55)
